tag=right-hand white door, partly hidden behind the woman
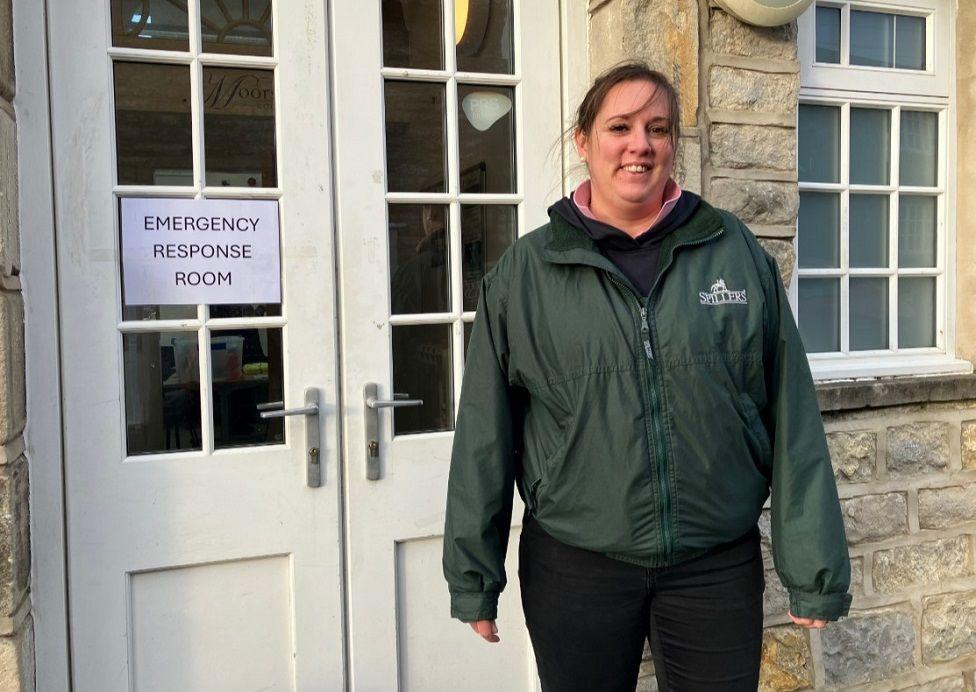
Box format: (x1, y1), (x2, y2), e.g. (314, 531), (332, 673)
(333, 0), (562, 691)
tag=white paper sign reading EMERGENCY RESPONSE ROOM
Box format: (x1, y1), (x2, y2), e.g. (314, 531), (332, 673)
(122, 197), (281, 305)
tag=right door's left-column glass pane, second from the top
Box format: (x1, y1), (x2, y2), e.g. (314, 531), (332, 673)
(385, 81), (447, 192)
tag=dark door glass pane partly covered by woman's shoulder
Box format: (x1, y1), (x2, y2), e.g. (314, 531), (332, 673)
(461, 204), (517, 310)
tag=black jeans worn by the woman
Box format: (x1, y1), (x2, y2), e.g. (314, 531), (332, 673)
(519, 517), (765, 692)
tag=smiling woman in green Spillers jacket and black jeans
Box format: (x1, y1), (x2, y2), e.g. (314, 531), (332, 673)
(444, 63), (850, 691)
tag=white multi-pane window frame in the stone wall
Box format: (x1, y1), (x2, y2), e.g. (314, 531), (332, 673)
(790, 0), (972, 380)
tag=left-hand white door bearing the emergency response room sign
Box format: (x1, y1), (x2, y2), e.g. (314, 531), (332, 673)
(48, 0), (345, 692)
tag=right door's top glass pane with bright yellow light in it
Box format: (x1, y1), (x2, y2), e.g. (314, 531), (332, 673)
(454, 0), (515, 74)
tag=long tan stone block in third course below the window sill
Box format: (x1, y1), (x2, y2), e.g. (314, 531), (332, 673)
(874, 536), (973, 593)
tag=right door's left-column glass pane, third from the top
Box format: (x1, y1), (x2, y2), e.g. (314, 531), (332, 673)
(388, 204), (451, 315)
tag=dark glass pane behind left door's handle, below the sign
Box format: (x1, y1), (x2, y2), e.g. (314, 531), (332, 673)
(210, 328), (280, 449)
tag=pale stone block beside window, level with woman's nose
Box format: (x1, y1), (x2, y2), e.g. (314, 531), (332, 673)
(710, 123), (796, 172)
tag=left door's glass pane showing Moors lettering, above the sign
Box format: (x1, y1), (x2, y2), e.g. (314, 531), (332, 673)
(203, 67), (278, 187)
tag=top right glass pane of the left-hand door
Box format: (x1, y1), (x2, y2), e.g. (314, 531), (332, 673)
(199, 0), (272, 56)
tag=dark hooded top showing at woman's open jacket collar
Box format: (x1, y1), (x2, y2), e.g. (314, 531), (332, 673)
(549, 190), (701, 296)
